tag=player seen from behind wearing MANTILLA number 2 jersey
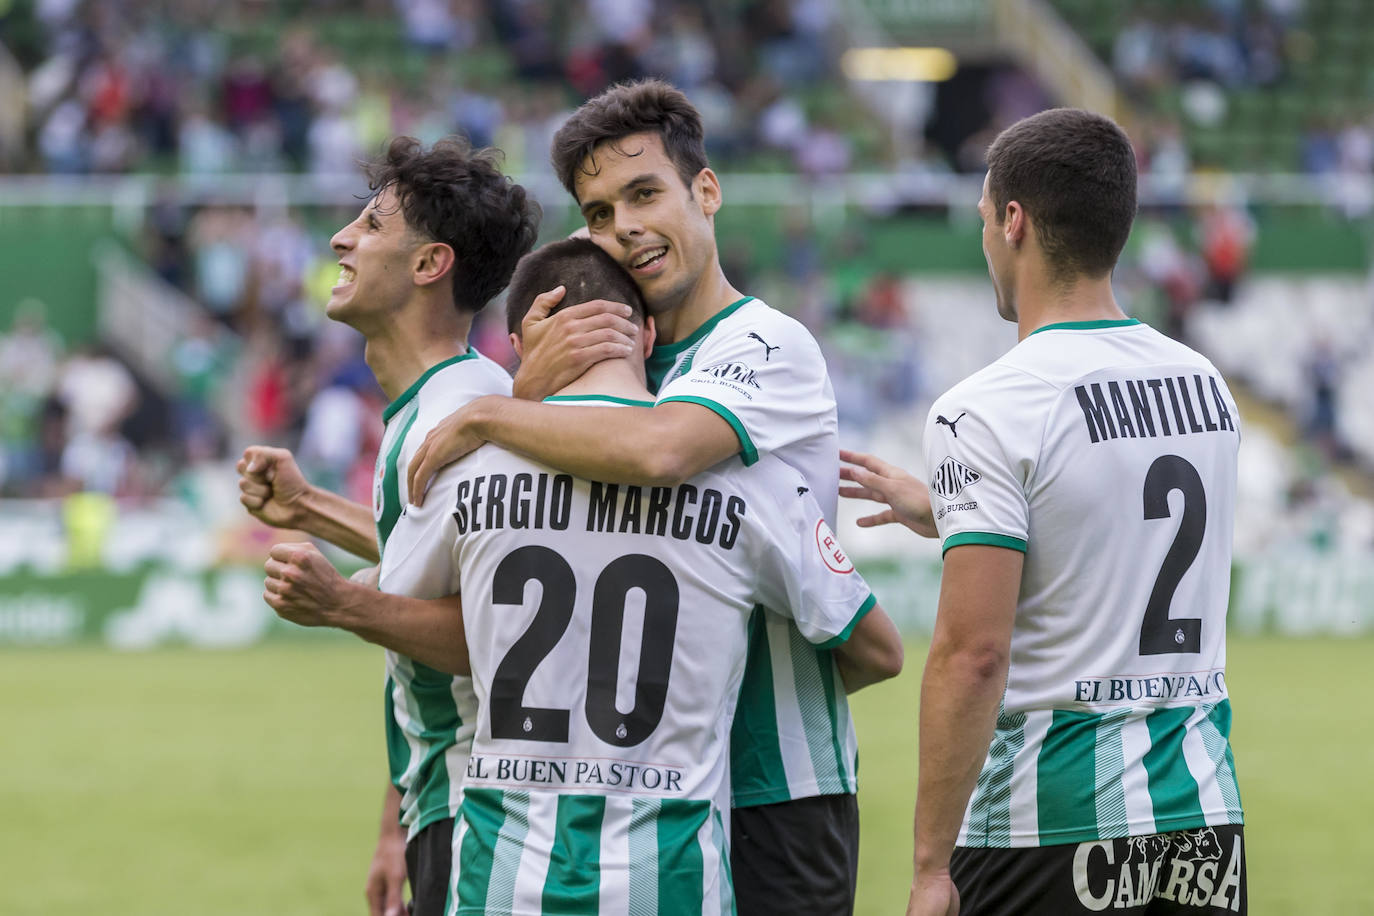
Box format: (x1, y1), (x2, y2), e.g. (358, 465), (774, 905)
(844, 108), (1246, 916)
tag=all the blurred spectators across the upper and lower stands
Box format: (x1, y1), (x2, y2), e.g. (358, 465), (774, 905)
(0, 0), (1374, 552)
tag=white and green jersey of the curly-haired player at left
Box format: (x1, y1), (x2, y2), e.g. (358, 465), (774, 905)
(372, 349), (511, 836)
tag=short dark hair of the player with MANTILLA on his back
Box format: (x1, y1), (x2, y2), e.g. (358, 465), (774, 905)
(987, 108), (1136, 280)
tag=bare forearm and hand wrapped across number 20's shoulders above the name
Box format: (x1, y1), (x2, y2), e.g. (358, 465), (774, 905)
(408, 396), (739, 505)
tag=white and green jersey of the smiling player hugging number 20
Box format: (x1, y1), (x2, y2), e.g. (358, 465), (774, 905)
(646, 297), (857, 808)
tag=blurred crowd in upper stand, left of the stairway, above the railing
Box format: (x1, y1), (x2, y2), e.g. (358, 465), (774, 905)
(0, 0), (879, 174)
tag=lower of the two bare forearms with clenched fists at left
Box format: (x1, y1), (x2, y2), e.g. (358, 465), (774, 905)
(262, 542), (471, 677)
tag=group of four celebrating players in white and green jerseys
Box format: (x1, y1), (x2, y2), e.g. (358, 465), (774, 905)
(239, 81), (1246, 916)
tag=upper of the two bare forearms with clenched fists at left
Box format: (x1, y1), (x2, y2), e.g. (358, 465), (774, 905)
(238, 445), (381, 563)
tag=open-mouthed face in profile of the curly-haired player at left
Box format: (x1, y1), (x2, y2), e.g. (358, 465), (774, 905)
(324, 188), (427, 330)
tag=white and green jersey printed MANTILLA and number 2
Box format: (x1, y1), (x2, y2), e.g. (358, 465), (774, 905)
(926, 320), (1242, 847)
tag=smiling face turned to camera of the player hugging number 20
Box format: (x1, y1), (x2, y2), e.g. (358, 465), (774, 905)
(576, 133), (720, 313)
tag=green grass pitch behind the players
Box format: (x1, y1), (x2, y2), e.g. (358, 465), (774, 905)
(0, 639), (1374, 916)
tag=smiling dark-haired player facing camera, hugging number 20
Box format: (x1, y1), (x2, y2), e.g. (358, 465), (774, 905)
(411, 80), (879, 916)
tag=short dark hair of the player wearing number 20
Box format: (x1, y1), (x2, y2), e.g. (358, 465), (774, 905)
(506, 239), (644, 334)
